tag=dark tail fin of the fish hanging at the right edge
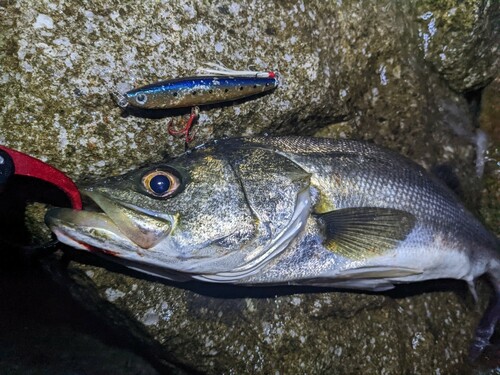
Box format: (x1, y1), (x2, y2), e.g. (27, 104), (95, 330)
(469, 261), (500, 361)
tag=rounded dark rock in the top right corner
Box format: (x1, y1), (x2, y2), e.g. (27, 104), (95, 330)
(416, 0), (500, 91)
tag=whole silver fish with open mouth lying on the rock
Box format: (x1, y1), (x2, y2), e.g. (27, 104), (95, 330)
(46, 136), (500, 358)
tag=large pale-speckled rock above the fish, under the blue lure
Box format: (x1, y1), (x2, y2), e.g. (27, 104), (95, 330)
(0, 0), (492, 179)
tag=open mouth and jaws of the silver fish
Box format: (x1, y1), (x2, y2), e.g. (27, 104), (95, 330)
(45, 190), (176, 255)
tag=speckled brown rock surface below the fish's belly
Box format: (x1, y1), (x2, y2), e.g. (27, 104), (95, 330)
(47, 263), (489, 374)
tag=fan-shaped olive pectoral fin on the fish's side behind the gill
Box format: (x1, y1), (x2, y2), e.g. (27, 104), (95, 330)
(320, 207), (416, 260)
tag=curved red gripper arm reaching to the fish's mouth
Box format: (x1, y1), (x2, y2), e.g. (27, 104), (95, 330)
(0, 145), (82, 210)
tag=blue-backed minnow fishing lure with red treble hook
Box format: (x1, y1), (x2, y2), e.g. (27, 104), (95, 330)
(115, 64), (279, 142)
